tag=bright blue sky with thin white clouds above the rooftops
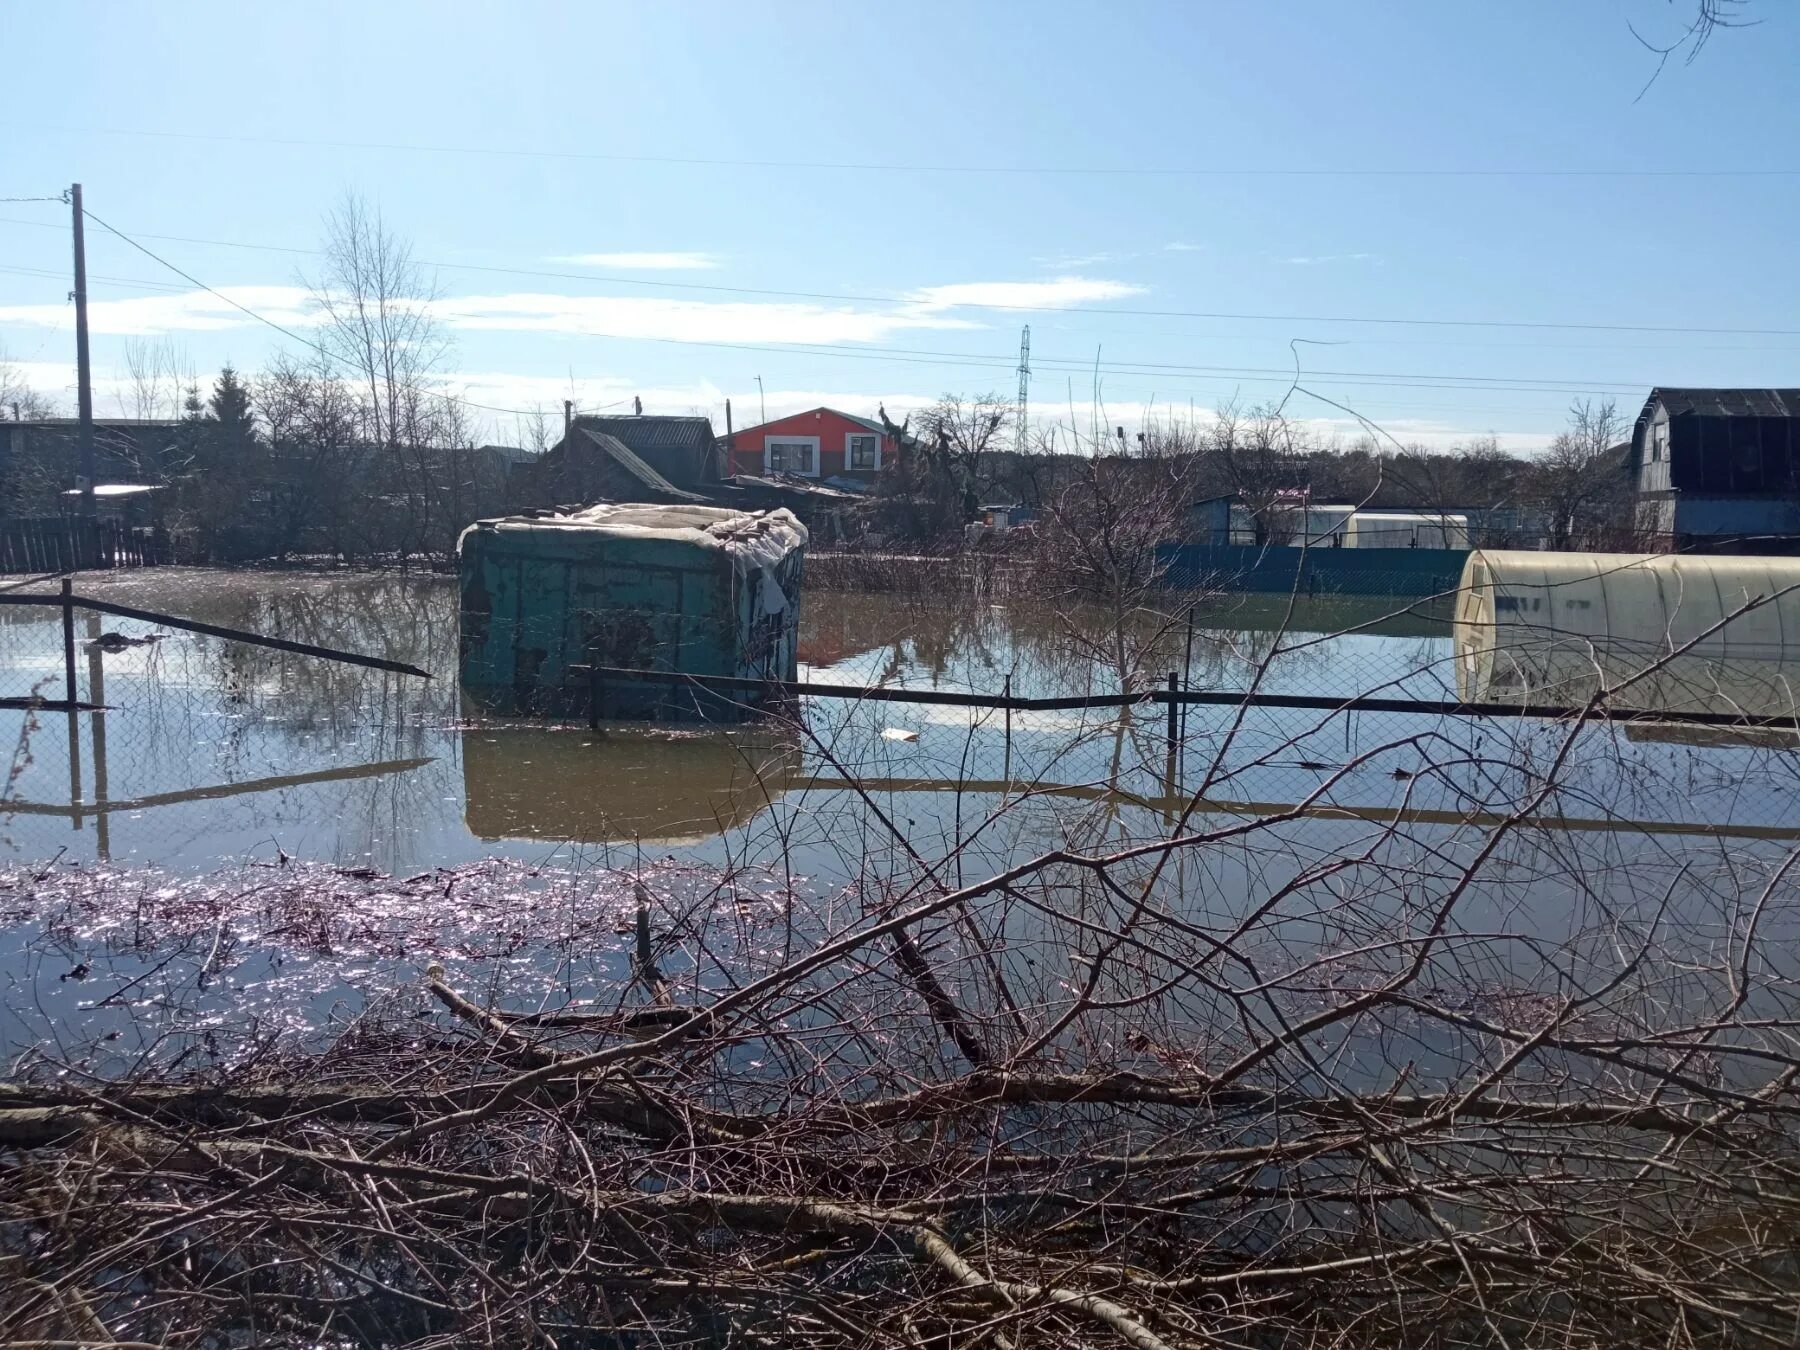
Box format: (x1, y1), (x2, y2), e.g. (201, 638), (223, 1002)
(0, 0), (1800, 450)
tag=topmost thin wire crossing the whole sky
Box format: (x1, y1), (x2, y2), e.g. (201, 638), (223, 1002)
(14, 121), (1800, 178)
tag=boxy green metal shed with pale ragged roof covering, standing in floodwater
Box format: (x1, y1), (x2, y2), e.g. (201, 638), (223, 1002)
(457, 506), (806, 720)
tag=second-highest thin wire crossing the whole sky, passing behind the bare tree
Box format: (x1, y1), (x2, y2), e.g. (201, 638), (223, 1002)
(0, 220), (1800, 337)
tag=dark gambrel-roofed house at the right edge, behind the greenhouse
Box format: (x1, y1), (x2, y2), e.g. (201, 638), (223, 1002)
(1627, 389), (1800, 553)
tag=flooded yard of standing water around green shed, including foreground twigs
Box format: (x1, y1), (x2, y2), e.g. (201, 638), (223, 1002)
(0, 572), (1800, 1350)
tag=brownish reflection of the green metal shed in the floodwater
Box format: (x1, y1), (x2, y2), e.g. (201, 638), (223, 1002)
(461, 727), (801, 844)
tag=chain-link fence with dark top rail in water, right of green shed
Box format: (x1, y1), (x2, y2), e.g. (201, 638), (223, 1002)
(592, 655), (1800, 841)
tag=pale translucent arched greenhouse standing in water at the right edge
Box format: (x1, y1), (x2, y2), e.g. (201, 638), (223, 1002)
(1454, 549), (1800, 716)
